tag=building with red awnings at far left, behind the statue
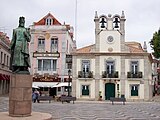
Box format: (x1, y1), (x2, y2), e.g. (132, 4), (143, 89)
(0, 32), (11, 95)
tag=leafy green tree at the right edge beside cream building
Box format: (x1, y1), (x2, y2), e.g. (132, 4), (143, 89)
(149, 29), (160, 59)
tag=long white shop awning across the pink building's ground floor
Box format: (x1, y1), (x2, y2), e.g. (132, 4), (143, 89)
(32, 82), (58, 88)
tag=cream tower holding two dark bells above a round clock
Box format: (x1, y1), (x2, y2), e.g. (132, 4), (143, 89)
(94, 11), (126, 52)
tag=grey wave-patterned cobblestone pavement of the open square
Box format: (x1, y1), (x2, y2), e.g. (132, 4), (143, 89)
(0, 97), (160, 120)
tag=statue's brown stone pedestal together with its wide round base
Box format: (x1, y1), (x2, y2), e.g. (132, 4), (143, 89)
(5, 74), (52, 120)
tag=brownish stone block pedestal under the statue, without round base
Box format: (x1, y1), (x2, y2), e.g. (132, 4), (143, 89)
(9, 74), (32, 117)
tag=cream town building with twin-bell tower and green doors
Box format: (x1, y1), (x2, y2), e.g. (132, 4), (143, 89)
(72, 12), (152, 100)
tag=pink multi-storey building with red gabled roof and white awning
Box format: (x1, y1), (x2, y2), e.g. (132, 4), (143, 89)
(30, 13), (76, 95)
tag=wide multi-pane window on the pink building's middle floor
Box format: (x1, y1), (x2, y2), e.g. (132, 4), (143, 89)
(38, 59), (57, 71)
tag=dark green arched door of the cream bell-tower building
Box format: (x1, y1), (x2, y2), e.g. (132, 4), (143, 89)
(105, 83), (115, 100)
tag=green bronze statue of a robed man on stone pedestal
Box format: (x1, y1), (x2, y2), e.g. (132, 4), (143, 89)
(10, 17), (31, 74)
